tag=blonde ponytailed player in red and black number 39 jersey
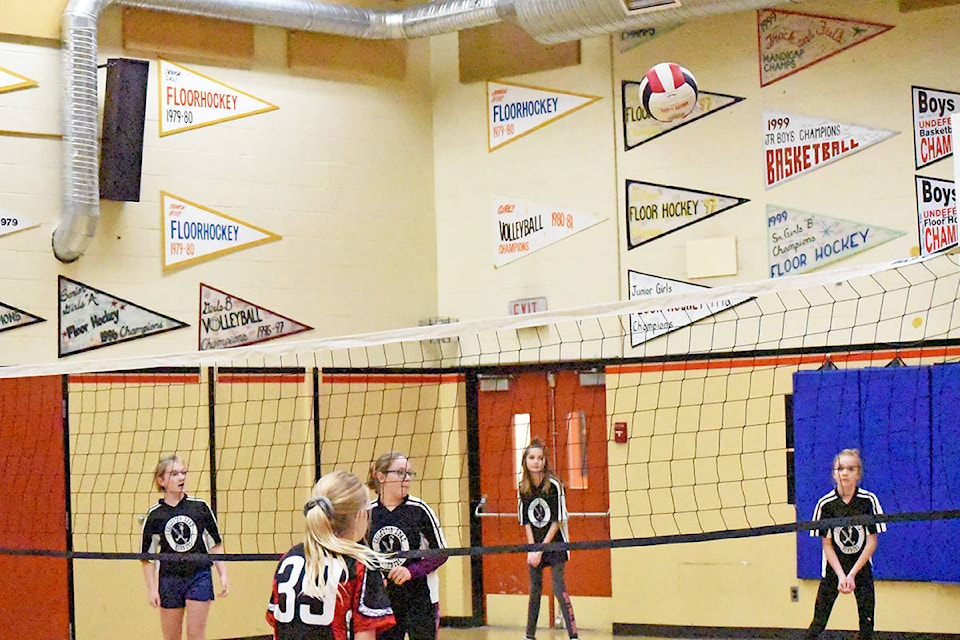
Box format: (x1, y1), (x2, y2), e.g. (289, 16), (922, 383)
(267, 471), (394, 640)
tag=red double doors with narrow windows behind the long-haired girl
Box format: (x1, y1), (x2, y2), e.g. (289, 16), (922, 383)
(478, 371), (611, 608)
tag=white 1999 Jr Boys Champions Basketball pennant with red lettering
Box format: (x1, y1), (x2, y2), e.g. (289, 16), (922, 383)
(763, 111), (898, 189)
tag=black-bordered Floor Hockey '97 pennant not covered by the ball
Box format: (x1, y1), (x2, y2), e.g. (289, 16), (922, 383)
(627, 180), (749, 250)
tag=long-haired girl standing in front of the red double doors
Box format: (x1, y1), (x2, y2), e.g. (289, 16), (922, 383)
(518, 439), (577, 640)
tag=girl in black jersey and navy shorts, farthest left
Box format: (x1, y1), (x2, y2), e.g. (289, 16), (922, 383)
(141, 454), (230, 640)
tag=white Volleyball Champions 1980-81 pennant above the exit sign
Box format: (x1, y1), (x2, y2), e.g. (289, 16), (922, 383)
(492, 196), (606, 267)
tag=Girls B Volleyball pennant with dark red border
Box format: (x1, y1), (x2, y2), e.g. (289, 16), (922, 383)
(199, 282), (313, 351)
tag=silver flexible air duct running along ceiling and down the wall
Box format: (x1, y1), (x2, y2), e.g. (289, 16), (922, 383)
(53, 0), (800, 262)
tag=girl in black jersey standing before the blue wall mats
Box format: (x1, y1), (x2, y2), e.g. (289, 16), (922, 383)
(806, 449), (886, 640)
